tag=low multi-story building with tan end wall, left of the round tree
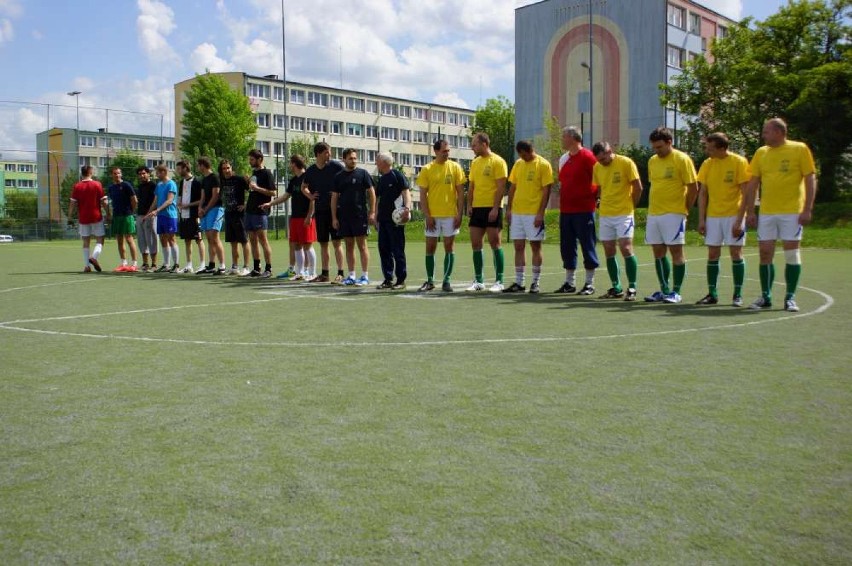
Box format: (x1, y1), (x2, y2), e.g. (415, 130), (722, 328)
(36, 128), (175, 221)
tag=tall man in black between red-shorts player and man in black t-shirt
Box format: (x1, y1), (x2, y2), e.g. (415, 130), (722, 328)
(302, 142), (343, 283)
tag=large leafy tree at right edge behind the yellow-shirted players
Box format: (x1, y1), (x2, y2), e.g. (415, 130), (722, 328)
(661, 0), (852, 201)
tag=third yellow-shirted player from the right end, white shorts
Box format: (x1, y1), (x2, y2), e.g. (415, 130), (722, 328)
(645, 127), (698, 303)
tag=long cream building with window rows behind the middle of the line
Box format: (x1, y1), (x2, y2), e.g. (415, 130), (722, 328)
(175, 72), (474, 180)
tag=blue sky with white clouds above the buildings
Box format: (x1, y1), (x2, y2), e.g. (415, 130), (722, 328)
(0, 0), (786, 159)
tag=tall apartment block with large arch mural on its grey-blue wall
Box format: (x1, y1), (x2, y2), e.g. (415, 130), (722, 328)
(515, 0), (733, 149)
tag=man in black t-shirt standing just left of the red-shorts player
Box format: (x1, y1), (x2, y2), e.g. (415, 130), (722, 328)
(246, 149), (276, 277)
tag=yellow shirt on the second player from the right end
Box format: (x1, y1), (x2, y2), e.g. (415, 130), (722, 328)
(698, 153), (751, 218)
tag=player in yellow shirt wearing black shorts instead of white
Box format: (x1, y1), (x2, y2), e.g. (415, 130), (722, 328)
(467, 132), (509, 293)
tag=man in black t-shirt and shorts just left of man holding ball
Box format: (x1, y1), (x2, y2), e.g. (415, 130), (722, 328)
(331, 148), (376, 287)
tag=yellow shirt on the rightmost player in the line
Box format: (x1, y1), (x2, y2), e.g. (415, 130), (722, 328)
(751, 140), (816, 214)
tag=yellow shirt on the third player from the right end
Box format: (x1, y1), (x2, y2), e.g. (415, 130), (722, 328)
(648, 149), (697, 215)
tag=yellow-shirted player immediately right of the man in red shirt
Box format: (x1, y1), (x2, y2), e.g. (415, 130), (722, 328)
(592, 142), (642, 301)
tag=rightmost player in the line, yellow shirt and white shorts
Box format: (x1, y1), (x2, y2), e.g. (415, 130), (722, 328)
(746, 118), (816, 312)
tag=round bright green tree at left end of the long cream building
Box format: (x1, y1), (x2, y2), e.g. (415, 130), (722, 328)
(180, 71), (257, 176)
